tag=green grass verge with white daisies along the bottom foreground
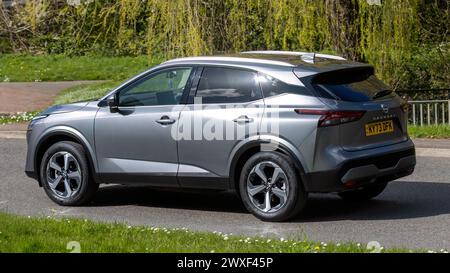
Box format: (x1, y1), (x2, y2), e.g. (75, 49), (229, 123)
(0, 210), (418, 253)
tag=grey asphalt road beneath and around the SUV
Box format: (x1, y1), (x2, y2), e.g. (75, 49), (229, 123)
(0, 139), (450, 250)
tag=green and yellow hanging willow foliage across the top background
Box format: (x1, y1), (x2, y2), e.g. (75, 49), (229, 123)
(0, 0), (450, 89)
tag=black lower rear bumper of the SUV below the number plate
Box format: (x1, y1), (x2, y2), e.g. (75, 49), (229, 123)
(304, 140), (416, 192)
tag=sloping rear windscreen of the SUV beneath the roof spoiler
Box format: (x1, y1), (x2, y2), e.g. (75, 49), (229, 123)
(313, 69), (394, 102)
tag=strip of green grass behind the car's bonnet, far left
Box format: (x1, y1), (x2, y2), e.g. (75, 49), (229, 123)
(0, 54), (161, 82)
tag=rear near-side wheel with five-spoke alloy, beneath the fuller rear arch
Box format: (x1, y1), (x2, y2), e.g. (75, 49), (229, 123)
(239, 152), (308, 222)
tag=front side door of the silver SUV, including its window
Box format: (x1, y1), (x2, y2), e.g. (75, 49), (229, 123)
(95, 67), (193, 187)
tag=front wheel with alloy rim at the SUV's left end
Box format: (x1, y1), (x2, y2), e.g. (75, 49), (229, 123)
(40, 141), (98, 206)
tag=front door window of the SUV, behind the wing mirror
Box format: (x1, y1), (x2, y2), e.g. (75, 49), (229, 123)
(119, 67), (192, 106)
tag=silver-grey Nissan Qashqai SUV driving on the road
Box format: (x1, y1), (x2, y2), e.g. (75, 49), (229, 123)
(26, 51), (416, 221)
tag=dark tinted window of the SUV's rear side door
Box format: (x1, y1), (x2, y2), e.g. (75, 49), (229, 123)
(196, 67), (262, 103)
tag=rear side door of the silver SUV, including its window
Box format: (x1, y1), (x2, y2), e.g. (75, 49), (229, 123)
(178, 66), (264, 188)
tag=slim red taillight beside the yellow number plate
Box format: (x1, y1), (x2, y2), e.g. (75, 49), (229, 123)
(295, 109), (366, 127)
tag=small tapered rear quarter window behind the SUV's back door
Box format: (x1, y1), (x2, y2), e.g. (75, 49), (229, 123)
(258, 73), (310, 98)
